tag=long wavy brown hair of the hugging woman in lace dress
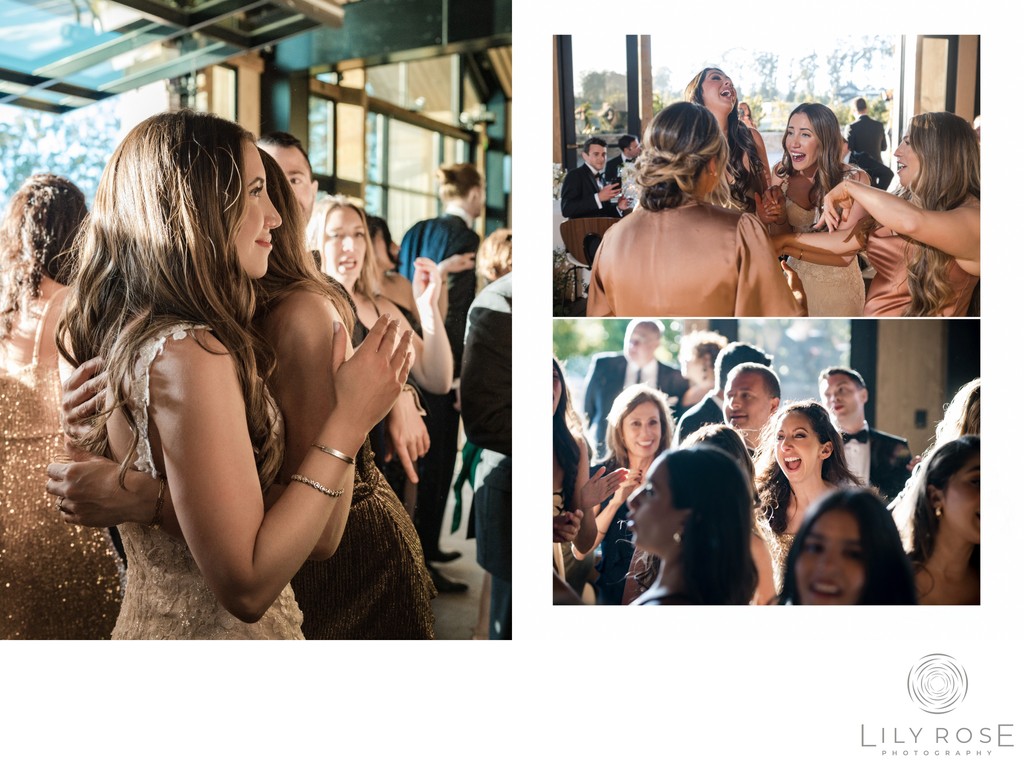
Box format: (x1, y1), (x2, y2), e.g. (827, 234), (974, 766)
(57, 110), (283, 487)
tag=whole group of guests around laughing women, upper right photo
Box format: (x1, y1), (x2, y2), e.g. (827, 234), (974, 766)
(561, 68), (981, 316)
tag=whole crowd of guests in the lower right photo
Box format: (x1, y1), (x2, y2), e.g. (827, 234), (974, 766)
(552, 320), (981, 604)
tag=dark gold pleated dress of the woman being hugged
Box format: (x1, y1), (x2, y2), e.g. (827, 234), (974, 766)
(292, 439), (437, 639)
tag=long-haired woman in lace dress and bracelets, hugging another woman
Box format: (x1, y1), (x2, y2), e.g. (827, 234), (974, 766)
(51, 111), (410, 638)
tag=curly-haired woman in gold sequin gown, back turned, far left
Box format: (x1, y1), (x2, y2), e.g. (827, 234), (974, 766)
(0, 174), (121, 639)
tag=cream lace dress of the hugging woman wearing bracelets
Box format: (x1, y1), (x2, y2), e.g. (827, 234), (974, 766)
(113, 325), (303, 639)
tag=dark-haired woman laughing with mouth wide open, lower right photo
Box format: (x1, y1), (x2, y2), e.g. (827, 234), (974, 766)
(754, 399), (859, 593)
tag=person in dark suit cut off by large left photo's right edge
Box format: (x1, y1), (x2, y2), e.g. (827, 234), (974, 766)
(462, 272), (512, 639)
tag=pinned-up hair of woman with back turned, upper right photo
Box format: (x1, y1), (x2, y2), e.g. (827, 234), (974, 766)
(637, 101), (729, 211)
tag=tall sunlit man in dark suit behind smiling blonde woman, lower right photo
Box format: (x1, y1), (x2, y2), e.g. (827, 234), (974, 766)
(584, 318), (689, 455)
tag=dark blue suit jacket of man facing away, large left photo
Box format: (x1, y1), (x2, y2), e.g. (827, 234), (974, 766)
(398, 215), (480, 374)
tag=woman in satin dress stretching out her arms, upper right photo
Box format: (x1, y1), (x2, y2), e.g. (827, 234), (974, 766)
(774, 112), (981, 316)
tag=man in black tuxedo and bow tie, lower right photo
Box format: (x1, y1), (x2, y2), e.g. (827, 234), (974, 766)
(818, 367), (912, 502)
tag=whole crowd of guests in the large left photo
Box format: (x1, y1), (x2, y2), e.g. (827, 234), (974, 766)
(0, 111), (511, 639)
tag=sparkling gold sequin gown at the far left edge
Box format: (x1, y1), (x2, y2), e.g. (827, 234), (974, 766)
(0, 291), (121, 639)
